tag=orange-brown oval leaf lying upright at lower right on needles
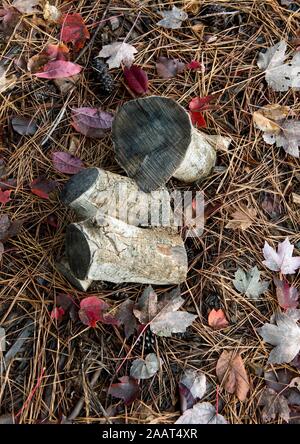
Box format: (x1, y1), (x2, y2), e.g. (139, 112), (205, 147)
(216, 350), (250, 401)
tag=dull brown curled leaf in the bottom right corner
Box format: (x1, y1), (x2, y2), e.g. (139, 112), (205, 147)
(258, 388), (290, 422)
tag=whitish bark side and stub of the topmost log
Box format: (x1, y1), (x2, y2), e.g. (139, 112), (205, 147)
(173, 128), (231, 183)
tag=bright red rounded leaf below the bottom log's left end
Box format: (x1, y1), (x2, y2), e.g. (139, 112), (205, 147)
(78, 296), (119, 328)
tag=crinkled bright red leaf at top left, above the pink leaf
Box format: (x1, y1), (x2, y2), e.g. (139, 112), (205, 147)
(60, 13), (90, 51)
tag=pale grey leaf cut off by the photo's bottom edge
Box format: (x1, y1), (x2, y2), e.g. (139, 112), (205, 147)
(175, 402), (227, 424)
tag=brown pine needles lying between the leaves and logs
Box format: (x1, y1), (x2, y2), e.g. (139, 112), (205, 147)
(0, 0), (300, 424)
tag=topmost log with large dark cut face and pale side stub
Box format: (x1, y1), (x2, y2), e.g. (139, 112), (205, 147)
(112, 96), (230, 192)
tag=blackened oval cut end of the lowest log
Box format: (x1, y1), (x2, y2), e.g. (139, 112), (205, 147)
(66, 224), (91, 279)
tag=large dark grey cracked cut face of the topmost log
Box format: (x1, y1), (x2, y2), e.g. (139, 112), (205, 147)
(112, 96), (191, 192)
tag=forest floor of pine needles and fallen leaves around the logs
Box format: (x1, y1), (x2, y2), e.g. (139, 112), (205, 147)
(0, 0), (300, 424)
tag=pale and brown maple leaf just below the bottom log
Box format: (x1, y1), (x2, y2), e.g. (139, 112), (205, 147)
(133, 285), (197, 336)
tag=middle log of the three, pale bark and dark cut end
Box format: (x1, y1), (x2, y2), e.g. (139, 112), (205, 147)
(61, 168), (172, 226)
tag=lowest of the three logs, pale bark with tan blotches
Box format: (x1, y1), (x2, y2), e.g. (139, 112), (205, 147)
(66, 214), (188, 285)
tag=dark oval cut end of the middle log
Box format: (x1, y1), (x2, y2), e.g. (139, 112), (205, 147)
(60, 168), (99, 205)
